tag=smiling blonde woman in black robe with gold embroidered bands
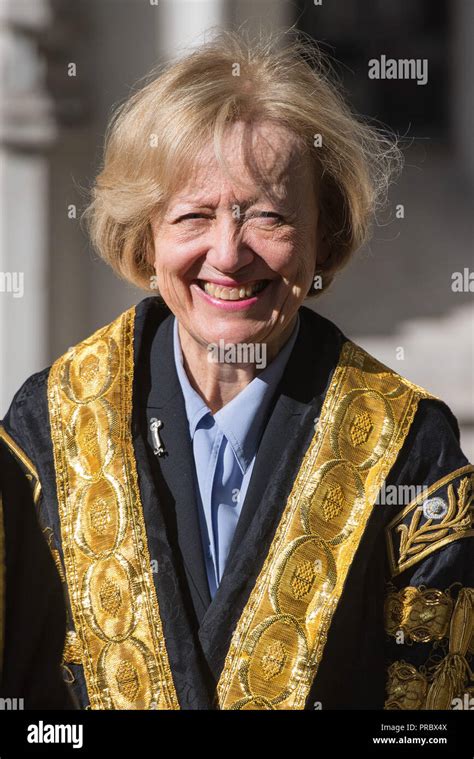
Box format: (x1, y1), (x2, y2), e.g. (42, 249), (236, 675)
(4, 28), (474, 709)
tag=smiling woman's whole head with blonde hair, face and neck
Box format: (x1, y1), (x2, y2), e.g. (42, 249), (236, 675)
(84, 33), (400, 410)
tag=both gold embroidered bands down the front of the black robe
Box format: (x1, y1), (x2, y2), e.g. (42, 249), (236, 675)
(48, 308), (430, 709)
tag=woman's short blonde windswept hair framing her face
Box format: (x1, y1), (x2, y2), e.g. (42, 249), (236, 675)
(83, 31), (401, 295)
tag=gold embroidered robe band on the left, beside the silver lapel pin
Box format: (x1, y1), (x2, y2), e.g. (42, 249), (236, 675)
(48, 309), (179, 709)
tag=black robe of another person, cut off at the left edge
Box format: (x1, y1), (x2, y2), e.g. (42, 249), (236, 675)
(0, 435), (74, 709)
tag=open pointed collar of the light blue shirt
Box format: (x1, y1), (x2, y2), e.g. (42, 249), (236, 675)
(173, 314), (300, 474)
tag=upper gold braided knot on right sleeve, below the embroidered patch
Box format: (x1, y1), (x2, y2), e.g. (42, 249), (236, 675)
(385, 586), (454, 643)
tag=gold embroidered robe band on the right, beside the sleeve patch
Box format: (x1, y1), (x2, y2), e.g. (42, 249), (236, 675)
(218, 342), (434, 709)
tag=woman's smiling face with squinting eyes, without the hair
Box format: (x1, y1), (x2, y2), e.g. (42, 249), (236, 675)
(152, 122), (318, 355)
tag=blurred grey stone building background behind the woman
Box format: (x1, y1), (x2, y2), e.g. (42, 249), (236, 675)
(0, 0), (474, 458)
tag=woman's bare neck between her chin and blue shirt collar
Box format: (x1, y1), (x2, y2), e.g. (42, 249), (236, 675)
(178, 315), (297, 414)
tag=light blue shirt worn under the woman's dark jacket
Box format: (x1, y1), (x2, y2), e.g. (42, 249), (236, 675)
(173, 314), (300, 598)
